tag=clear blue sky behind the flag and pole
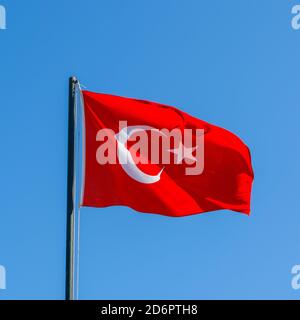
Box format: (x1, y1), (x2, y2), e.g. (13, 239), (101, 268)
(0, 0), (300, 299)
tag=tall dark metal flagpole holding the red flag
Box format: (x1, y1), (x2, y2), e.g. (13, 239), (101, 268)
(65, 77), (78, 300)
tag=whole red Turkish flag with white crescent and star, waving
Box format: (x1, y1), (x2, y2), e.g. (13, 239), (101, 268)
(81, 91), (253, 217)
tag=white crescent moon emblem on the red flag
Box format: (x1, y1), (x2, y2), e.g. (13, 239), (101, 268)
(115, 126), (164, 184)
